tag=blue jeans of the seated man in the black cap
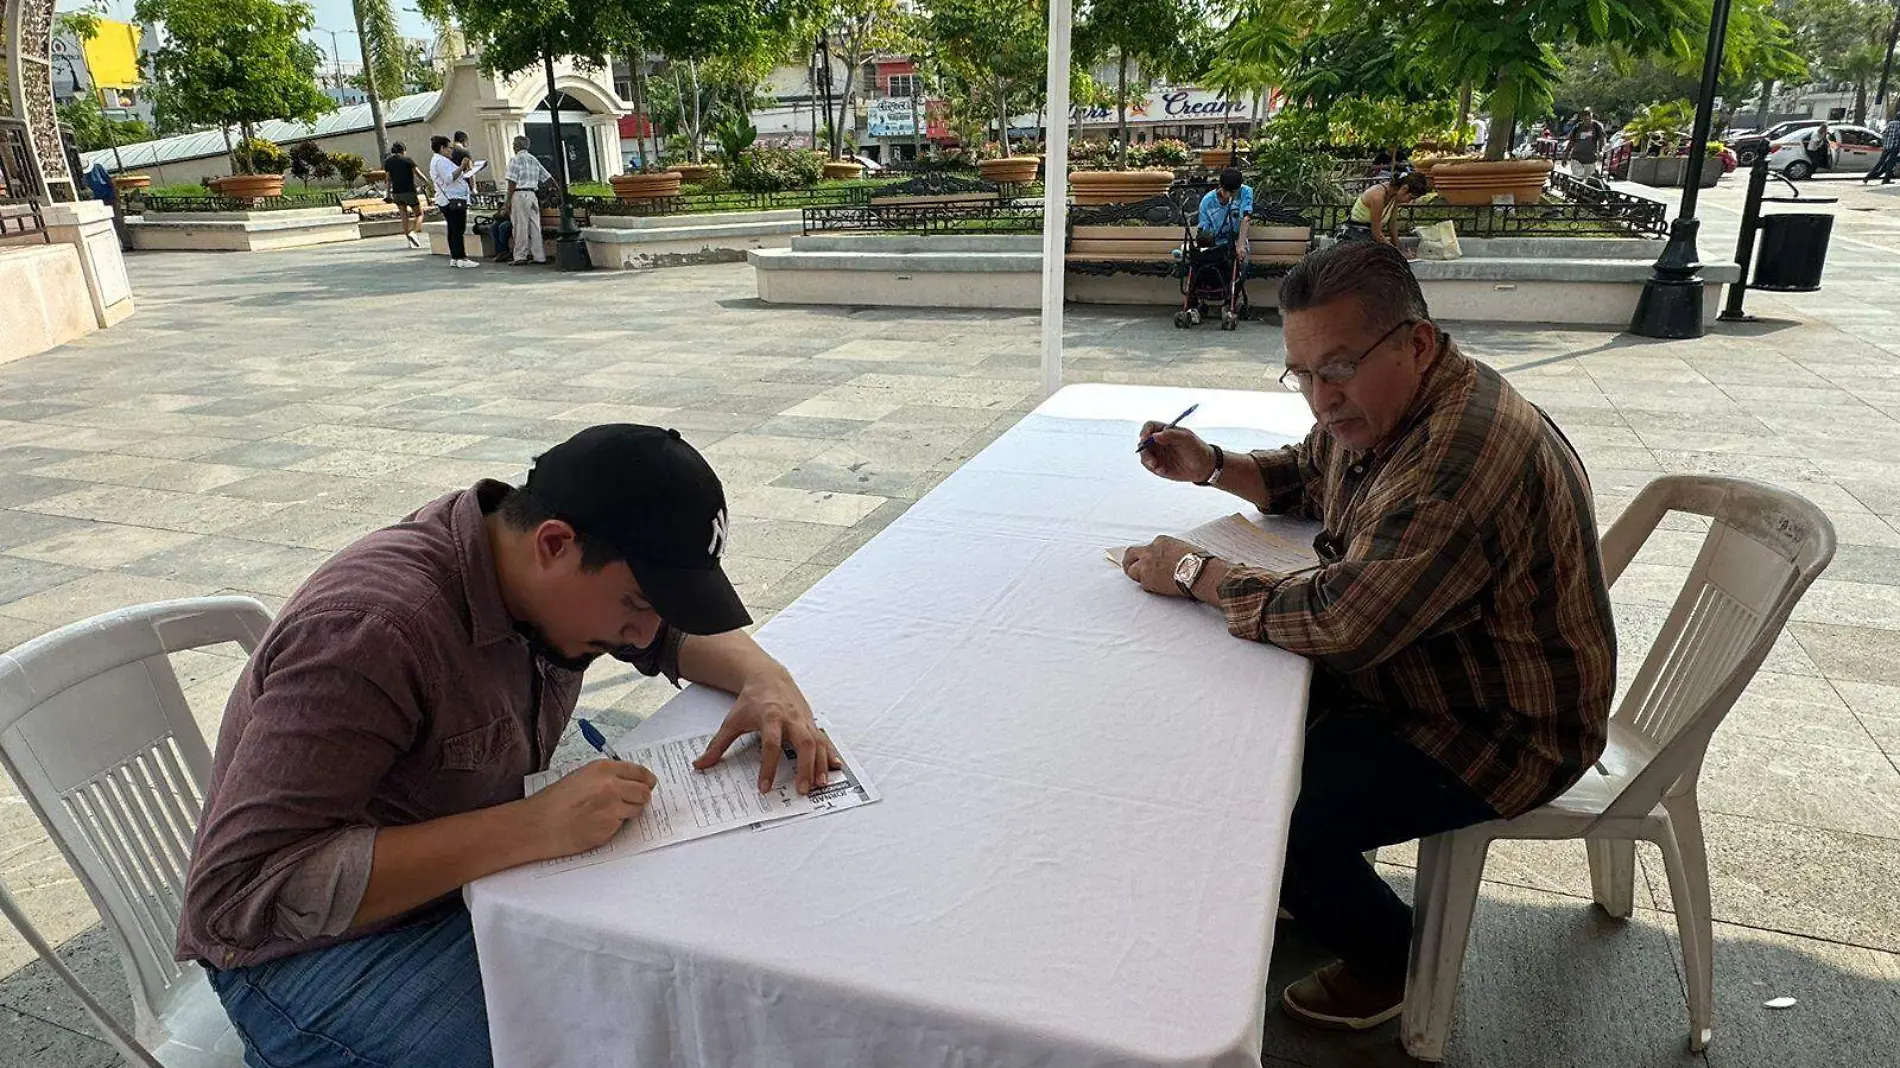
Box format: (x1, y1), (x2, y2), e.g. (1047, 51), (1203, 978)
(205, 899), (490, 1068)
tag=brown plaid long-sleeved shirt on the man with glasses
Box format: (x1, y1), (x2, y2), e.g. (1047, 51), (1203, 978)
(1220, 336), (1617, 815)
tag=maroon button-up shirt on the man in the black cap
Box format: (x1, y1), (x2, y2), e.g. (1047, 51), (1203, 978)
(177, 483), (680, 969)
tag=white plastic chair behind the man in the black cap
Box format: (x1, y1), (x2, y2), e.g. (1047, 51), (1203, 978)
(0, 597), (270, 1068)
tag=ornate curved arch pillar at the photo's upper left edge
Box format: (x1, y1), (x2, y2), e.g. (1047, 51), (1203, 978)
(0, 0), (78, 201)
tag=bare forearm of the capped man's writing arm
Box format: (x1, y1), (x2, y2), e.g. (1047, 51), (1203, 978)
(350, 802), (547, 927)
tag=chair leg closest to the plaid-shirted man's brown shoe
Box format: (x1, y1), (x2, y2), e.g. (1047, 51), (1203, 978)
(1398, 830), (1492, 1060)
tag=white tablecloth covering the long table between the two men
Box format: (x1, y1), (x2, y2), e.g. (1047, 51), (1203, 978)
(467, 386), (1311, 1068)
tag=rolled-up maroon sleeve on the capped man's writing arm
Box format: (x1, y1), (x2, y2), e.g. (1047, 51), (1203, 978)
(186, 612), (428, 950)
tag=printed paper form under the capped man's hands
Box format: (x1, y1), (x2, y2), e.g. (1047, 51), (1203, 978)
(523, 722), (880, 878)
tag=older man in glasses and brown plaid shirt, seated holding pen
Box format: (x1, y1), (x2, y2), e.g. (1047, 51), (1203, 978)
(1125, 243), (1617, 1030)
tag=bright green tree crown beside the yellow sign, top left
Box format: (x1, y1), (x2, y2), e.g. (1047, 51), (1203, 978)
(135, 0), (334, 153)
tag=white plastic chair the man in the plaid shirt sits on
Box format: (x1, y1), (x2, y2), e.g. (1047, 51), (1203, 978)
(1400, 475), (1834, 1060)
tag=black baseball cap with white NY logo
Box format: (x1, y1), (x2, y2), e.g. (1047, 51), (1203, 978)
(523, 424), (752, 635)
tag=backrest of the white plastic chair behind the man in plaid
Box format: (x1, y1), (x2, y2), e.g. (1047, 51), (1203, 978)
(1602, 475), (1834, 817)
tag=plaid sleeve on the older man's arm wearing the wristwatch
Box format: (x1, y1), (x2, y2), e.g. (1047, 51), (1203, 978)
(1220, 500), (1492, 673)
